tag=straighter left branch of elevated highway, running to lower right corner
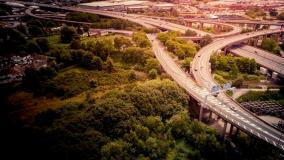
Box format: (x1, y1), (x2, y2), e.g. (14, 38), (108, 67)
(148, 31), (284, 150)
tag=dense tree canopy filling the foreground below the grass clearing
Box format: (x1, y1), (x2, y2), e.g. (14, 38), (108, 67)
(4, 80), (225, 159)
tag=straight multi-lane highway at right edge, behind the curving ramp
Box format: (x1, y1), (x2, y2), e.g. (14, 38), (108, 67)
(229, 45), (284, 76)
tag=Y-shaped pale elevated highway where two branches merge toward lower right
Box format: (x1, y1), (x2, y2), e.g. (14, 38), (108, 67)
(148, 31), (284, 151)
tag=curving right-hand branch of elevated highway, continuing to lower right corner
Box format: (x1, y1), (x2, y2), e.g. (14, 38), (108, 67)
(192, 29), (284, 150)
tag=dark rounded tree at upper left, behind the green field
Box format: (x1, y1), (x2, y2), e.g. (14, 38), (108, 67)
(60, 26), (79, 43)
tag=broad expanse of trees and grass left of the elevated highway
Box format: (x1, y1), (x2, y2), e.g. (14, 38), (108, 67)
(0, 23), (231, 159)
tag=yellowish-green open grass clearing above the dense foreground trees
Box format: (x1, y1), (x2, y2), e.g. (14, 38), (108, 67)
(3, 66), (147, 116)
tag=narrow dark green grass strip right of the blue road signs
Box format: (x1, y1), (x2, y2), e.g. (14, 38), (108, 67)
(237, 90), (284, 106)
